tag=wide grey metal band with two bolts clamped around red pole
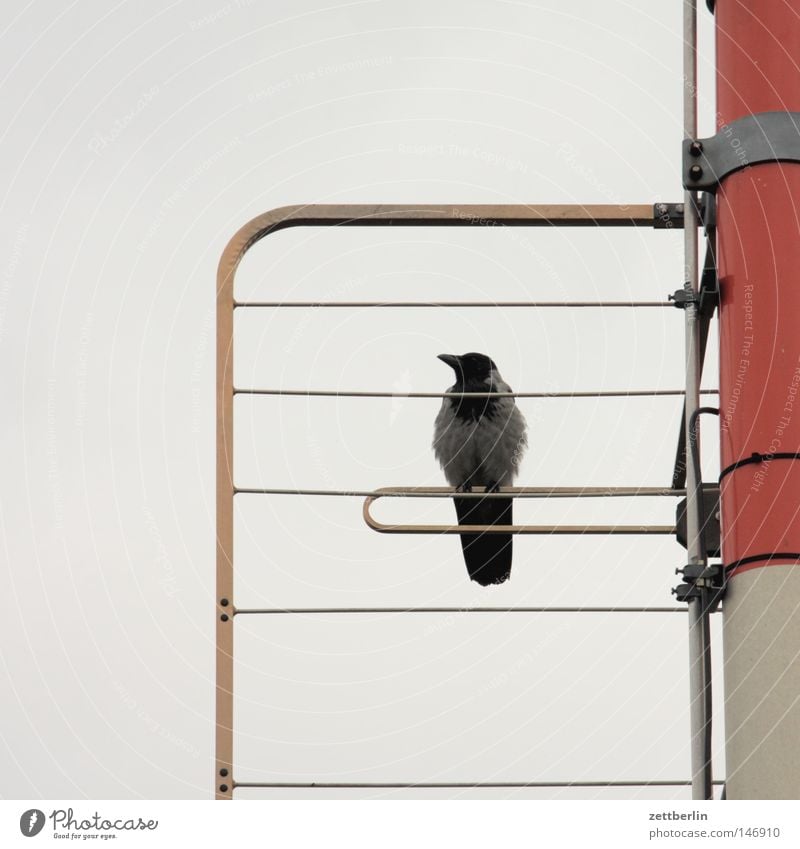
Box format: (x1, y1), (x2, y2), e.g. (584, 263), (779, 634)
(683, 112), (800, 192)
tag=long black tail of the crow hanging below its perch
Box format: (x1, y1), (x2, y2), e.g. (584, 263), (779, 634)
(453, 497), (513, 587)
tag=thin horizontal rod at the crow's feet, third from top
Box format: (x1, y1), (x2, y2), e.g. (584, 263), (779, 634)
(234, 486), (686, 499)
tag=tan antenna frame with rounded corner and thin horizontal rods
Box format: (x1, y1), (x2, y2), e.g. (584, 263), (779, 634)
(214, 204), (715, 799)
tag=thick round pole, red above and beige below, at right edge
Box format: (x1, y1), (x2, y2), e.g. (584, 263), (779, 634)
(715, 0), (800, 799)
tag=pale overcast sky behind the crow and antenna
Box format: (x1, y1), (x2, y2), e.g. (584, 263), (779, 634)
(0, 0), (724, 799)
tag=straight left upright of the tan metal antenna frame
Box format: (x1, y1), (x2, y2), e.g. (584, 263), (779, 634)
(214, 242), (236, 799)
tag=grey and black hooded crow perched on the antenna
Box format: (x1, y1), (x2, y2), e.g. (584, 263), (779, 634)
(433, 352), (528, 586)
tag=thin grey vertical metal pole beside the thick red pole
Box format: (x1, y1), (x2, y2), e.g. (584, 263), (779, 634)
(683, 0), (712, 799)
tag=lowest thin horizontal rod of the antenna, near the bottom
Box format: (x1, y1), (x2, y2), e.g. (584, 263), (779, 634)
(234, 779), (724, 790)
